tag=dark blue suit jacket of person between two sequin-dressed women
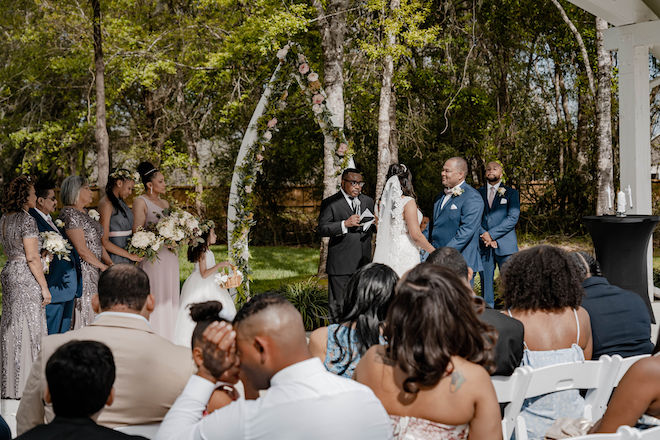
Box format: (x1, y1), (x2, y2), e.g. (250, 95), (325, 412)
(29, 208), (82, 303)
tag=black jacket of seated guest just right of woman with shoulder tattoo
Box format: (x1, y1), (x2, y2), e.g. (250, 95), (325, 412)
(479, 308), (525, 376)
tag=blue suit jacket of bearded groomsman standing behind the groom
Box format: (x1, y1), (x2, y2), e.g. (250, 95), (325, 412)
(479, 185), (520, 255)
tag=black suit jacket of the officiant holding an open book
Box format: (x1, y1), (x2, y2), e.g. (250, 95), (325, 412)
(318, 191), (375, 275)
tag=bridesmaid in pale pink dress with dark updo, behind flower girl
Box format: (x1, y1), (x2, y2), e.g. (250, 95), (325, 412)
(133, 162), (179, 341)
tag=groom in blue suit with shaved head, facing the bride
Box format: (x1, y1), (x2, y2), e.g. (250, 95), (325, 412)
(425, 157), (484, 272)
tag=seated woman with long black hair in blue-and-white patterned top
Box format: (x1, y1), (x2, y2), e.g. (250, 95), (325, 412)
(309, 262), (398, 378)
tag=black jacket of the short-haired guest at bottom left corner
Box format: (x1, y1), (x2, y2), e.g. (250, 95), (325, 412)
(15, 417), (145, 440)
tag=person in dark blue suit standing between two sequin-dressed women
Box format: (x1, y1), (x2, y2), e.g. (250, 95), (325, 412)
(29, 182), (82, 335)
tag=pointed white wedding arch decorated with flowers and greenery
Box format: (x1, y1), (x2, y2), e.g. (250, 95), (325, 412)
(227, 42), (353, 301)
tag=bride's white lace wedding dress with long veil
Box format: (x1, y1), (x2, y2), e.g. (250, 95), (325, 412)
(373, 176), (422, 277)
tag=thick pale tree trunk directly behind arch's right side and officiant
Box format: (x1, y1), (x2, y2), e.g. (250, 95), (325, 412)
(312, 0), (349, 275)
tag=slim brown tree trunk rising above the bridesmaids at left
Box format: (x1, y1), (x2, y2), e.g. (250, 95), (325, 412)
(91, 0), (110, 189)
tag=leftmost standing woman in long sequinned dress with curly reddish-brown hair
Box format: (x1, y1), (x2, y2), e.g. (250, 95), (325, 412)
(0, 176), (50, 399)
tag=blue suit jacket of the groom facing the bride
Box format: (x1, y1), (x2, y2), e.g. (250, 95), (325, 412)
(426, 182), (484, 272)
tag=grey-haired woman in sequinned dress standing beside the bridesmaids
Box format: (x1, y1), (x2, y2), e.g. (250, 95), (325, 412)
(59, 176), (113, 329)
